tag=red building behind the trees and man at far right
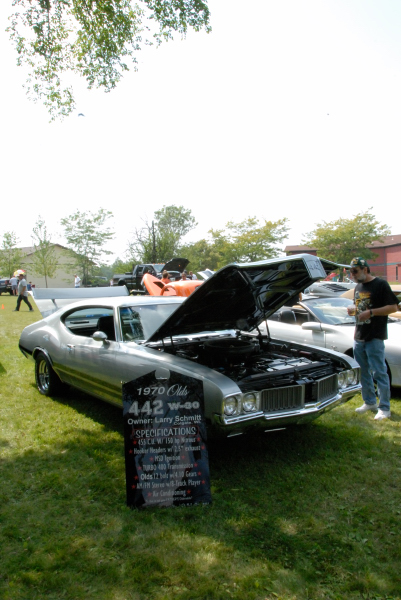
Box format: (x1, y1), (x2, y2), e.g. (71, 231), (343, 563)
(284, 235), (401, 281)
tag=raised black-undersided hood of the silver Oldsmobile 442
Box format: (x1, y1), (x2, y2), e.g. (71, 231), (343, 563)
(147, 254), (337, 342)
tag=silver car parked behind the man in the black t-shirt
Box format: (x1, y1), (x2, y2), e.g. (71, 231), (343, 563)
(267, 296), (401, 387)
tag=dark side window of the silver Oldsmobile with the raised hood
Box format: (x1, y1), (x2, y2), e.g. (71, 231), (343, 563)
(64, 306), (116, 340)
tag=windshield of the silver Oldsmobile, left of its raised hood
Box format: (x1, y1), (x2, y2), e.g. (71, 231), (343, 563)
(120, 302), (179, 342)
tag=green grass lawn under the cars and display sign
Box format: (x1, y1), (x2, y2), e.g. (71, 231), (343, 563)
(0, 296), (401, 600)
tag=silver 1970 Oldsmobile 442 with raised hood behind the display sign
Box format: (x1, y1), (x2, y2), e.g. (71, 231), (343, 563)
(19, 254), (361, 436)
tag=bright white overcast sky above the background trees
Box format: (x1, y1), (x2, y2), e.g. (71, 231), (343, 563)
(0, 0), (401, 261)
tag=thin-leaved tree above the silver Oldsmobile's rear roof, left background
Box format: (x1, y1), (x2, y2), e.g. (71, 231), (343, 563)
(61, 208), (114, 282)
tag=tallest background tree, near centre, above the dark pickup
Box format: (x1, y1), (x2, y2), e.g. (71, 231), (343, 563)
(129, 205), (197, 263)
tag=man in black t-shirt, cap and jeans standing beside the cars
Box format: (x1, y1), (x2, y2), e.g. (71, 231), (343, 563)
(348, 256), (397, 420)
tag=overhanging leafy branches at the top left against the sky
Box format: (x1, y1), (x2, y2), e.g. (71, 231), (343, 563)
(8, 0), (210, 119)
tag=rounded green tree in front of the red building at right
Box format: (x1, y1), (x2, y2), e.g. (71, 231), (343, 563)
(303, 208), (390, 264)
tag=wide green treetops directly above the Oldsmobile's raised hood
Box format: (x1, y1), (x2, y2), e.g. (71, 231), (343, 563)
(180, 217), (288, 271)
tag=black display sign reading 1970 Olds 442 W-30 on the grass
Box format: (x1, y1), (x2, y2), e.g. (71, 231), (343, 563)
(123, 369), (212, 508)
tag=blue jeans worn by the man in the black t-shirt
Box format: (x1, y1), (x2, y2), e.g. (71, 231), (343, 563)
(354, 339), (391, 410)
